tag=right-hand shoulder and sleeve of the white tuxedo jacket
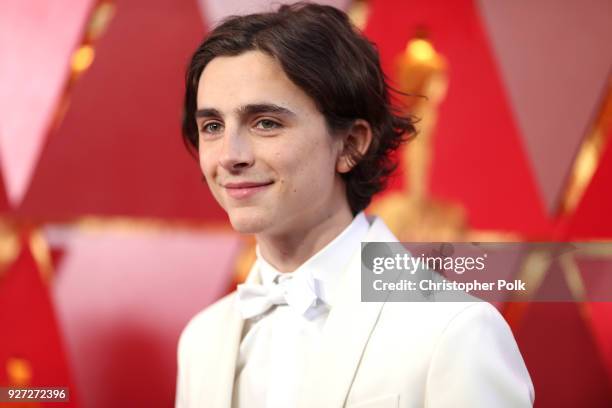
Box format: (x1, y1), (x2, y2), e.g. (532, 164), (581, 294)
(426, 302), (535, 407)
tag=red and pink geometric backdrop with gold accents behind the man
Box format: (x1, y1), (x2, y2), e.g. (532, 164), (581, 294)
(0, 0), (612, 407)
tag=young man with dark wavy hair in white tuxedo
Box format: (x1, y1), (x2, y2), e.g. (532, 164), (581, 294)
(176, 4), (534, 408)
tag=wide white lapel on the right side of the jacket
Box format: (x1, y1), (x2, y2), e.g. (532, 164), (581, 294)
(298, 219), (397, 408)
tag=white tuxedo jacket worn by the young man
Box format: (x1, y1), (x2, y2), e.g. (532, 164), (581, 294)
(176, 218), (534, 408)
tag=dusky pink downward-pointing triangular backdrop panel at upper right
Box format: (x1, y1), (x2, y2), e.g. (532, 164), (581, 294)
(479, 0), (612, 214)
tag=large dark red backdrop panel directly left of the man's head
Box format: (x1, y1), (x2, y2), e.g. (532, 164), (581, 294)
(20, 0), (223, 220)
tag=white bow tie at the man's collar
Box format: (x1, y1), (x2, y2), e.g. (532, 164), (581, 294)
(237, 274), (319, 319)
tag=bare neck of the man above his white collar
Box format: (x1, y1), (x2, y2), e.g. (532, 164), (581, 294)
(257, 208), (353, 272)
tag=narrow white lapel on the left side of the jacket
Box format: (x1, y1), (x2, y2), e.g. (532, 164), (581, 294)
(198, 263), (259, 408)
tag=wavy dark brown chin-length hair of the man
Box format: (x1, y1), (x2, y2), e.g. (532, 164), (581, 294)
(182, 3), (415, 214)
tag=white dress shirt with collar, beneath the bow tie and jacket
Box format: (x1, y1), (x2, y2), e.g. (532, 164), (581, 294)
(232, 212), (369, 408)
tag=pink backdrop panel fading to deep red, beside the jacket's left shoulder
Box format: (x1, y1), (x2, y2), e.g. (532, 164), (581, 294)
(46, 228), (240, 407)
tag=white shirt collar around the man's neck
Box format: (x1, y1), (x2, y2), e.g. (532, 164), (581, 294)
(255, 211), (370, 306)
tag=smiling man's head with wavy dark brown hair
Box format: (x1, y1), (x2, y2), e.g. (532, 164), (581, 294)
(183, 4), (414, 236)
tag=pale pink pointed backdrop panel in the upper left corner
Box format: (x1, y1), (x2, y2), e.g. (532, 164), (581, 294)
(0, 0), (95, 206)
